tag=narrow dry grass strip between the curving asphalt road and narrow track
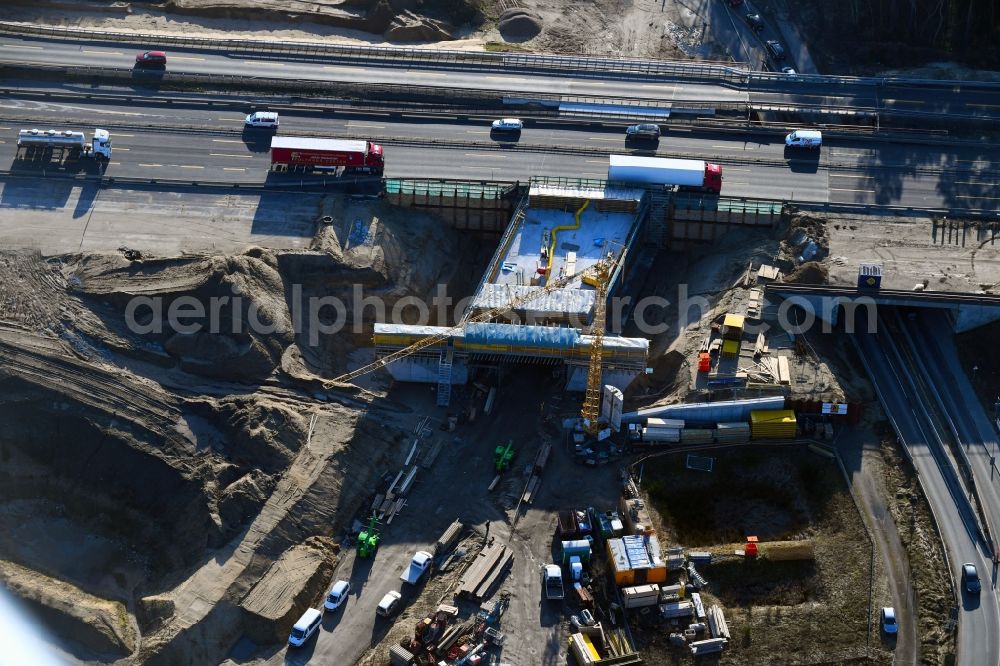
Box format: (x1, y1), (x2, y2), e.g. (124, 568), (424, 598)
(881, 430), (955, 664)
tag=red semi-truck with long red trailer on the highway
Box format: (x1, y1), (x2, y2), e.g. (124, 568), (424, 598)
(271, 136), (385, 176)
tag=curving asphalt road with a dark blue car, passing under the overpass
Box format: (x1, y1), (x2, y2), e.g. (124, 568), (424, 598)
(852, 320), (1000, 665)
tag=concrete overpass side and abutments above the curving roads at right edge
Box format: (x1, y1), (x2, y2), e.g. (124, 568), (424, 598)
(765, 282), (1000, 333)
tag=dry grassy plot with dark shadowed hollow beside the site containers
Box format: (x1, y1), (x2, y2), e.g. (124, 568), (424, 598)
(636, 447), (891, 664)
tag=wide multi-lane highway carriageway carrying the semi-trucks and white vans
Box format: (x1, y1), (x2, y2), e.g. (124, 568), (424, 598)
(0, 96), (1000, 208)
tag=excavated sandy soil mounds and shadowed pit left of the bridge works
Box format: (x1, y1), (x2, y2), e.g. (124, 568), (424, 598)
(0, 196), (480, 663)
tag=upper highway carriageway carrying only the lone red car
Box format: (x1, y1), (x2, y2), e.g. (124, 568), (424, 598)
(0, 36), (1000, 118)
